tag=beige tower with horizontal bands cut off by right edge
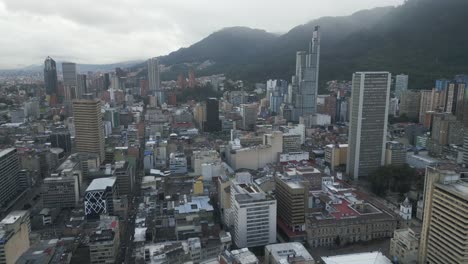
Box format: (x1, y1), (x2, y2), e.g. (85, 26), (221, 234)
(418, 167), (468, 264)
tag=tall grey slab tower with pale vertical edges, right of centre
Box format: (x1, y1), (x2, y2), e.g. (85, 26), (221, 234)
(346, 72), (392, 179)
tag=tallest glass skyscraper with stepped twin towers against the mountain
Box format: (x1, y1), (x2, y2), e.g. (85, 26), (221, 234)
(292, 26), (320, 121)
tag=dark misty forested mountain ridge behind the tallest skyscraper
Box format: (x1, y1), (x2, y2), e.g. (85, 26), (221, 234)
(161, 0), (468, 89)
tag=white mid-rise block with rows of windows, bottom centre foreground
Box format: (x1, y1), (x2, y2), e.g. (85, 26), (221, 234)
(231, 180), (276, 248)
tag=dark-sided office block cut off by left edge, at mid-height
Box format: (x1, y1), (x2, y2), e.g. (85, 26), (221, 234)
(0, 148), (20, 207)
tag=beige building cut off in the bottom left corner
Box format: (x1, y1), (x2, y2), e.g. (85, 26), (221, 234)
(0, 211), (31, 264)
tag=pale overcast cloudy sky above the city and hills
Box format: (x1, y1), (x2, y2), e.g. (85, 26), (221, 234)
(0, 0), (403, 69)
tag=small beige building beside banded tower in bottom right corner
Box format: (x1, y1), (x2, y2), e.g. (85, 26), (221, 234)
(390, 228), (420, 264)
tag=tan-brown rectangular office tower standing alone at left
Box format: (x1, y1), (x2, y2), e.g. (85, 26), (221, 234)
(73, 99), (105, 161)
